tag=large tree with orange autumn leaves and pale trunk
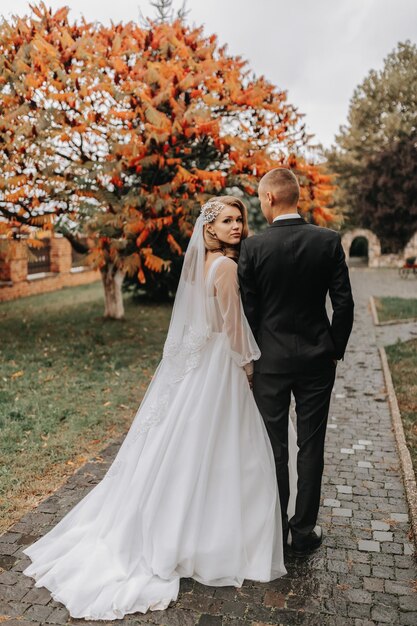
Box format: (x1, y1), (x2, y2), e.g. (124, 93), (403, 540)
(0, 3), (333, 318)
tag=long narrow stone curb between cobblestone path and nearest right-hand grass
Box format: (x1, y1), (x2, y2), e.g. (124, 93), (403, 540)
(379, 347), (417, 551)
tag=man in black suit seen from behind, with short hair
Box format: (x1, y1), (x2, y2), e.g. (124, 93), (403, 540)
(238, 168), (353, 556)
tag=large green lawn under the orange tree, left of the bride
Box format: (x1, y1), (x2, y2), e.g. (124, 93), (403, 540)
(0, 283), (171, 532)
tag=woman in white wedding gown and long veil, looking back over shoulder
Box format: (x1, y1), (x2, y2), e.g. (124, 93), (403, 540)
(24, 196), (296, 620)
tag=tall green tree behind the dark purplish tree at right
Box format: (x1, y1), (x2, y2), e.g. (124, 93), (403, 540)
(326, 41), (417, 248)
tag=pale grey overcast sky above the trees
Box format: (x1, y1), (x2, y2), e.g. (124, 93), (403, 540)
(0, 0), (417, 146)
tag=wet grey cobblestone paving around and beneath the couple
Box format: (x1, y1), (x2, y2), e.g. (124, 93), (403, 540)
(0, 268), (417, 626)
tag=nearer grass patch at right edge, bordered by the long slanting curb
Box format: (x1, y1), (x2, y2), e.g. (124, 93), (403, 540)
(385, 339), (417, 473)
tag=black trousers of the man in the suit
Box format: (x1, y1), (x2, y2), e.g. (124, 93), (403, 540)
(253, 362), (336, 541)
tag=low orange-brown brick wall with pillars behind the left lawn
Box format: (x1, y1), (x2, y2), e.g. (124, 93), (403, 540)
(0, 236), (101, 302)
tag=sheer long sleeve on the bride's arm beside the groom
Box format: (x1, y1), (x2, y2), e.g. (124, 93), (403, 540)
(214, 258), (261, 367)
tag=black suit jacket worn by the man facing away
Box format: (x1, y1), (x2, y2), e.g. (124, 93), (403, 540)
(238, 217), (354, 373)
